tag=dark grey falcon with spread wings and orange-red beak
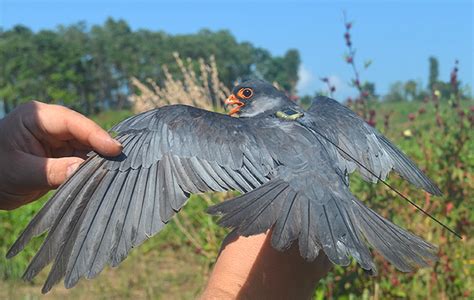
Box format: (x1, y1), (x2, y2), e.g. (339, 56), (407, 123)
(7, 80), (441, 293)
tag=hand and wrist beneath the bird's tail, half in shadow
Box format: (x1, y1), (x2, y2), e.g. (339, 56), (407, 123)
(201, 232), (332, 300)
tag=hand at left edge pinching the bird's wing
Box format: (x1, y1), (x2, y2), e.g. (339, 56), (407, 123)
(0, 101), (122, 210)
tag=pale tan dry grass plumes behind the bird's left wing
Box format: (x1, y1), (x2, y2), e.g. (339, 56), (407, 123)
(129, 52), (230, 113)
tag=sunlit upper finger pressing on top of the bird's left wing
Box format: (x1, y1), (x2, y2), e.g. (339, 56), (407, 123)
(26, 103), (122, 156)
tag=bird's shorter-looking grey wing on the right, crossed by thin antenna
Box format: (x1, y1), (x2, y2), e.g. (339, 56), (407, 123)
(301, 96), (441, 195)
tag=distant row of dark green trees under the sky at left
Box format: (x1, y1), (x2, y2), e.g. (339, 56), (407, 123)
(0, 18), (300, 114)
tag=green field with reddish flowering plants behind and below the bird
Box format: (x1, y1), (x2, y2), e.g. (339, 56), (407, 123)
(0, 99), (474, 299)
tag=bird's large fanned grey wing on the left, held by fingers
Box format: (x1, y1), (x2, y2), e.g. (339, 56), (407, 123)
(7, 105), (284, 292)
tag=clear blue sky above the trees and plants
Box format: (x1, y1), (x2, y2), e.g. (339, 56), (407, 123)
(0, 0), (474, 99)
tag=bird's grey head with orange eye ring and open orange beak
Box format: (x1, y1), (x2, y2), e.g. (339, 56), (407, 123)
(225, 80), (294, 117)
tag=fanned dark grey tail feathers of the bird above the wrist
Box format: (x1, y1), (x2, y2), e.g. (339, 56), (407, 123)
(208, 179), (437, 274)
